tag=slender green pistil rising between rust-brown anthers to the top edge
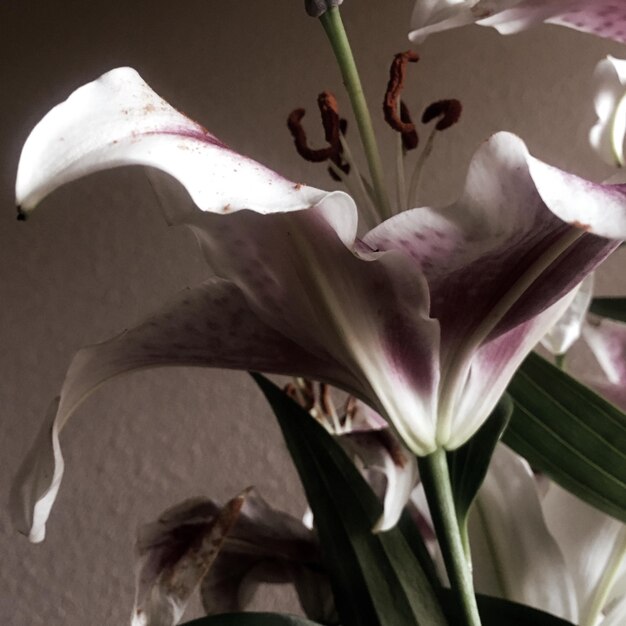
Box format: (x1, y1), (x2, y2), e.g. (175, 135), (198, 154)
(320, 7), (391, 219)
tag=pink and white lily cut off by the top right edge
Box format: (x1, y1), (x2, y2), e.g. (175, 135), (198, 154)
(409, 0), (626, 43)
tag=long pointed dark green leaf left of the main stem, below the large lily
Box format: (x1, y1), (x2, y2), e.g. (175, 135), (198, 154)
(253, 374), (446, 626)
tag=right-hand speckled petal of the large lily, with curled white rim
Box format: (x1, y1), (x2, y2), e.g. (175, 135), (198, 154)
(364, 133), (626, 447)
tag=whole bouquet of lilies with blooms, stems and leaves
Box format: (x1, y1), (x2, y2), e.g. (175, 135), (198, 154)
(12, 0), (626, 626)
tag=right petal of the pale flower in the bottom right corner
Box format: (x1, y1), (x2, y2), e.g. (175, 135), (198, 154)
(542, 484), (626, 624)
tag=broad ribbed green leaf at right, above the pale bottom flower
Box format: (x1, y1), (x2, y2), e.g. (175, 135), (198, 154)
(503, 354), (626, 522)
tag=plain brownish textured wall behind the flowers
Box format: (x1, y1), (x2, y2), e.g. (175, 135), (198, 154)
(0, 0), (626, 626)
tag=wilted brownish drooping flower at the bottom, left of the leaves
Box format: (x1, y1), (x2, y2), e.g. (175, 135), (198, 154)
(132, 490), (336, 626)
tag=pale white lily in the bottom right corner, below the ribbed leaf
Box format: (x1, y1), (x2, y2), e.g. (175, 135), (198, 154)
(469, 445), (626, 626)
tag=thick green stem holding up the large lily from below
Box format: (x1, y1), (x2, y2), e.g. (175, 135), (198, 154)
(418, 448), (481, 626)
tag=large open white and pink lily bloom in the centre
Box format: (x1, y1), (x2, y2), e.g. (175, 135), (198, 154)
(13, 68), (626, 540)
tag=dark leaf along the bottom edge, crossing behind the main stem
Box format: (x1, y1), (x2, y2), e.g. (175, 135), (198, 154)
(443, 589), (573, 626)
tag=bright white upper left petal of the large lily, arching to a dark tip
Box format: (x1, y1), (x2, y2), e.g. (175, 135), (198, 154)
(16, 68), (324, 213)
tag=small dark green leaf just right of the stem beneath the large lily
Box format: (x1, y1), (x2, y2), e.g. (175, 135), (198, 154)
(448, 396), (513, 529)
